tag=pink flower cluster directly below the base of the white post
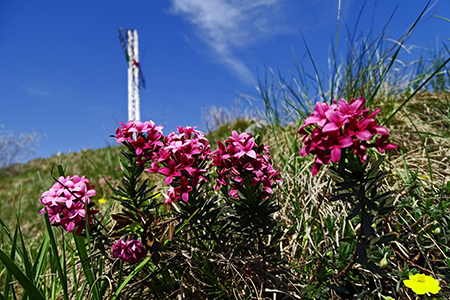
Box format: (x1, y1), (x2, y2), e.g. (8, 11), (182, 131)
(112, 121), (164, 165)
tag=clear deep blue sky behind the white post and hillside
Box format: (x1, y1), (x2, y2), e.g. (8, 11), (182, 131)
(0, 0), (450, 162)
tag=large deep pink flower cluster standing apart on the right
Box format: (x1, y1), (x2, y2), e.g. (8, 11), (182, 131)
(298, 98), (397, 175)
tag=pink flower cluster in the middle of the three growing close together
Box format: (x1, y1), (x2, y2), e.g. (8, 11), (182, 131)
(145, 126), (210, 204)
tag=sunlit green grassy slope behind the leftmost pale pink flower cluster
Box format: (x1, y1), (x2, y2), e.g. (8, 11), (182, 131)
(0, 147), (121, 244)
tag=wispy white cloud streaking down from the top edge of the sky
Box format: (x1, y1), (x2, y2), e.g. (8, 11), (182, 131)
(171, 0), (286, 82)
